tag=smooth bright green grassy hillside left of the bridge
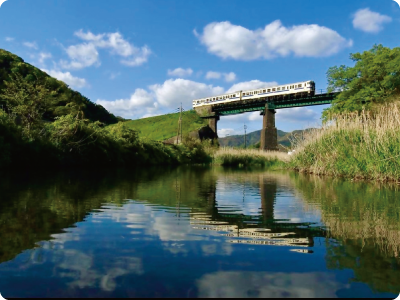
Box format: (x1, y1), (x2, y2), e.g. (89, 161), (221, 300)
(124, 110), (208, 141)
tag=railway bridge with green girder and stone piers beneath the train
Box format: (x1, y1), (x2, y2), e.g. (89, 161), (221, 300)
(195, 90), (337, 150)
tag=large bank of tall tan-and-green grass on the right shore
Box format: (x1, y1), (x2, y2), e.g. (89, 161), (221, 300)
(290, 103), (400, 181)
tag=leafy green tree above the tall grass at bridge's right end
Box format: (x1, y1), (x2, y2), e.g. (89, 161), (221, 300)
(323, 45), (400, 120)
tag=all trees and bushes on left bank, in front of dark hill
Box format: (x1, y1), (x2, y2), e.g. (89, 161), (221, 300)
(0, 60), (211, 168)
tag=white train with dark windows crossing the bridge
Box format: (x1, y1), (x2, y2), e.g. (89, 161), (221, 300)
(193, 80), (315, 107)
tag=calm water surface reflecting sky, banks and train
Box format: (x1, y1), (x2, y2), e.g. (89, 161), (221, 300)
(0, 167), (400, 297)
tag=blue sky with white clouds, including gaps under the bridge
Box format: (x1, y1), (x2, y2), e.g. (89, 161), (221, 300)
(0, 0), (400, 136)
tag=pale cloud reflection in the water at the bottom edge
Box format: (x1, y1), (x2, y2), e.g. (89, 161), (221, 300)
(197, 272), (347, 298)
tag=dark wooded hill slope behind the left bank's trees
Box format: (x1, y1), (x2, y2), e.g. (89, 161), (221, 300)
(0, 49), (118, 124)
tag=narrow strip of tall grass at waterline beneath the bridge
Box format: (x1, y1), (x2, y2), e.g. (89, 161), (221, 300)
(213, 147), (288, 167)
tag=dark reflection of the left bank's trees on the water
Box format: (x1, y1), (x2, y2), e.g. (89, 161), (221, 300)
(0, 171), (142, 262)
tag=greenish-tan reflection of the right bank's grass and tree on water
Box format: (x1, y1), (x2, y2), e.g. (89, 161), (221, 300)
(294, 175), (400, 293)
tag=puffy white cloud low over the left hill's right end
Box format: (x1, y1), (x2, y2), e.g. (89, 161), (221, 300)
(96, 89), (158, 118)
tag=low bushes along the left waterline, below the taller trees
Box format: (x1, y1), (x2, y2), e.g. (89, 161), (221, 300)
(0, 109), (211, 169)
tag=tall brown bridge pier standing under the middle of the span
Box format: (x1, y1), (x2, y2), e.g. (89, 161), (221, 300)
(260, 103), (278, 151)
